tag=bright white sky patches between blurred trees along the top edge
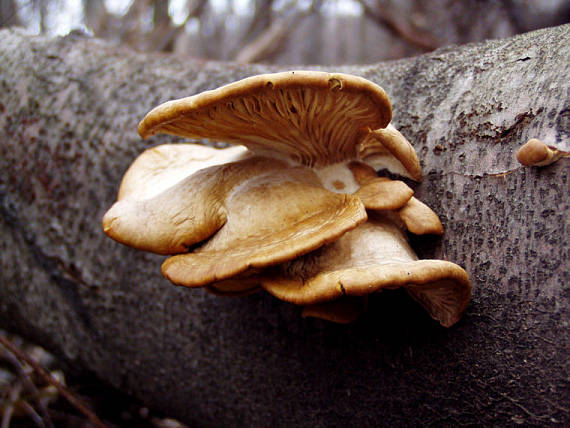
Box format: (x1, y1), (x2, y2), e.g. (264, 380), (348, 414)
(18, 0), (362, 35)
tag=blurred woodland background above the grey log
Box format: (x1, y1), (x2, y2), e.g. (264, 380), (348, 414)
(0, 0), (570, 65)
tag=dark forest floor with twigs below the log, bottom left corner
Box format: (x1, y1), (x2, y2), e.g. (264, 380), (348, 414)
(0, 330), (186, 428)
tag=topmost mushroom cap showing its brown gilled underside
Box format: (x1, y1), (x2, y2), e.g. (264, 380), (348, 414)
(138, 71), (392, 166)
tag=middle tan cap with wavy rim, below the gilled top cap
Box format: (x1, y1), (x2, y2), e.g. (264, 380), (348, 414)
(162, 167), (367, 287)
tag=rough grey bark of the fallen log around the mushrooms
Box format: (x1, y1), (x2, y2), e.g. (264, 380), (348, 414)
(0, 26), (570, 426)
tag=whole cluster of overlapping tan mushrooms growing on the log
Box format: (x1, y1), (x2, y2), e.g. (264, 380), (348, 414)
(103, 71), (471, 327)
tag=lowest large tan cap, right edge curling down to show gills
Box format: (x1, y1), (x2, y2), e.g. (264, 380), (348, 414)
(255, 215), (471, 327)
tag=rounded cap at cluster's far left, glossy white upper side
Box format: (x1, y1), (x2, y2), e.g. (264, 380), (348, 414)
(103, 144), (251, 254)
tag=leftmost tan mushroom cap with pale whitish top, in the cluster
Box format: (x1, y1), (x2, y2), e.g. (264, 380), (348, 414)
(103, 144), (287, 254)
